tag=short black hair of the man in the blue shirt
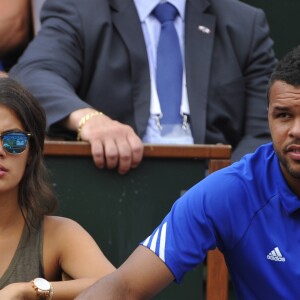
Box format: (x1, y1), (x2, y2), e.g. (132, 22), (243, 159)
(267, 46), (300, 104)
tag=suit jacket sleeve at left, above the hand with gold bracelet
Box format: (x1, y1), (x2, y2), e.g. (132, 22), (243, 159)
(9, 0), (88, 126)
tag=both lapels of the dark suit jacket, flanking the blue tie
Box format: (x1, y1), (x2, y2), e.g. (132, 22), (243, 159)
(110, 0), (215, 139)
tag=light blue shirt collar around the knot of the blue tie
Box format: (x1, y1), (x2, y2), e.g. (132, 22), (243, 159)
(134, 0), (186, 22)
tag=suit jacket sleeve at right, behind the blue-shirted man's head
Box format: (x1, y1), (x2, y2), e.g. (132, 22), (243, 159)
(232, 10), (277, 161)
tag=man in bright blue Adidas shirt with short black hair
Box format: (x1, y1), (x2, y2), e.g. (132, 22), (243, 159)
(76, 47), (300, 300)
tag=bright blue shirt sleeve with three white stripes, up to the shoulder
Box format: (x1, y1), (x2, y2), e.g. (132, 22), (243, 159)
(141, 164), (255, 282)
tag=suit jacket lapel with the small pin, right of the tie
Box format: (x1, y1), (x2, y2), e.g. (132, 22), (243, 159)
(185, 0), (215, 143)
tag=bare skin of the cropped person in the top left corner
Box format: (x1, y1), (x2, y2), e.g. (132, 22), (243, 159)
(0, 0), (31, 56)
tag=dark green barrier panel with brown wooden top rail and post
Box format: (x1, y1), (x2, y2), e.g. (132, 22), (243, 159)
(44, 141), (231, 300)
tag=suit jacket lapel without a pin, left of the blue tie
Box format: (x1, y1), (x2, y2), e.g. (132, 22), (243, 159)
(110, 0), (150, 136)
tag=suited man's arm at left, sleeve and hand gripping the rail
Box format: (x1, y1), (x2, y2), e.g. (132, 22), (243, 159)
(10, 0), (143, 174)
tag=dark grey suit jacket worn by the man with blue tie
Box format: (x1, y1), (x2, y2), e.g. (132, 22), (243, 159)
(10, 0), (275, 159)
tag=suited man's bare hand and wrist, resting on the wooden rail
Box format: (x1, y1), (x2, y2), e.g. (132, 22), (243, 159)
(64, 108), (144, 174)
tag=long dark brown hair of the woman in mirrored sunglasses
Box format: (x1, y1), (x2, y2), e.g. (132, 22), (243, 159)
(0, 77), (57, 227)
